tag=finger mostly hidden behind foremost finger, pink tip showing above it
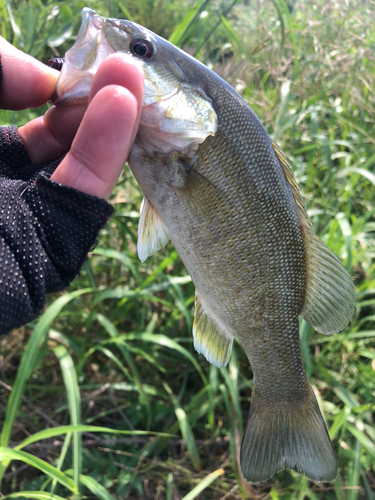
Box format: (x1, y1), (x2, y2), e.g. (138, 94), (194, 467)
(18, 54), (143, 163)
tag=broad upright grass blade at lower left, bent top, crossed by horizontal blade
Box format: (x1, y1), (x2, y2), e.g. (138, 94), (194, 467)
(53, 346), (82, 494)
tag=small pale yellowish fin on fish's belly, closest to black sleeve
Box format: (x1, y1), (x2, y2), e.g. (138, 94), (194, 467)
(137, 197), (169, 262)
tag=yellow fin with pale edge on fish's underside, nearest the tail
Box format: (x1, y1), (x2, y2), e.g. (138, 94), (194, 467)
(193, 294), (233, 368)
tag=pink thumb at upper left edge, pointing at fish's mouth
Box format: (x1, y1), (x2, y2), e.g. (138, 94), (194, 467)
(0, 37), (59, 110)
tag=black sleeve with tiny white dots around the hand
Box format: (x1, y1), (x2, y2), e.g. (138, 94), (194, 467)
(0, 127), (113, 333)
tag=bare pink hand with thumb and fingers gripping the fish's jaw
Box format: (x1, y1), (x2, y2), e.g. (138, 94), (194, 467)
(0, 37), (143, 199)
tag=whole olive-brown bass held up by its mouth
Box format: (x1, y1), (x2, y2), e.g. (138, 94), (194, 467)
(54, 8), (355, 483)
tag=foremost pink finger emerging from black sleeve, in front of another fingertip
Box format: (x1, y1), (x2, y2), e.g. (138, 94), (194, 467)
(51, 85), (138, 199)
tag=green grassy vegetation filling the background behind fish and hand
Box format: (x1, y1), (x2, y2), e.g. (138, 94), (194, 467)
(0, 0), (375, 500)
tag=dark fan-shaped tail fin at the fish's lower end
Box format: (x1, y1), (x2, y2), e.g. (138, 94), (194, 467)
(240, 388), (337, 483)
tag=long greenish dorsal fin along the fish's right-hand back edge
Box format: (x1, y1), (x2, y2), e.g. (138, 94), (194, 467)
(272, 142), (355, 335)
